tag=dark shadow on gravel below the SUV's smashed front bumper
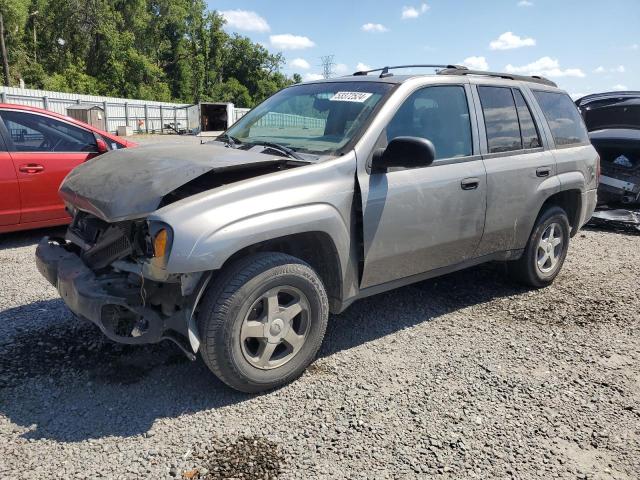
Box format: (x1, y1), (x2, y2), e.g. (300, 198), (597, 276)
(0, 300), (251, 442)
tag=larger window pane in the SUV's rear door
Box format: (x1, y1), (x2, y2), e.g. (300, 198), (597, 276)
(478, 87), (522, 153)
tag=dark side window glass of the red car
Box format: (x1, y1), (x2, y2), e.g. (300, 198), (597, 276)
(0, 110), (97, 153)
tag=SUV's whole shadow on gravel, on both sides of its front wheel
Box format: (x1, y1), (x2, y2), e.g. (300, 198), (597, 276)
(0, 265), (524, 442)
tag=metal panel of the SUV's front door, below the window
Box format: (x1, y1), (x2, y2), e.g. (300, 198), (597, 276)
(362, 160), (487, 288)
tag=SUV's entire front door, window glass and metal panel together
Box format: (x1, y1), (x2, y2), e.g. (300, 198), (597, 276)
(358, 84), (487, 288)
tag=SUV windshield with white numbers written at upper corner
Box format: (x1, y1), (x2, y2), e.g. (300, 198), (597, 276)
(226, 82), (392, 155)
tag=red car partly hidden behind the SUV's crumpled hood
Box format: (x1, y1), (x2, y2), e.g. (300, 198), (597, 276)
(0, 103), (136, 233)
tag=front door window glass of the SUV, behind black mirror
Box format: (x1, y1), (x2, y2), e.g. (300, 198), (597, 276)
(387, 85), (473, 160)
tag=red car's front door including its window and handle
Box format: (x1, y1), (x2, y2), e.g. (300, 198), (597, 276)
(0, 109), (97, 223)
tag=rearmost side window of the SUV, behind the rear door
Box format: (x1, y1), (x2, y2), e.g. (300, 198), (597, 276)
(533, 91), (589, 147)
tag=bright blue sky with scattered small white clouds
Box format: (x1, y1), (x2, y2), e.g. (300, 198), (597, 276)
(209, 0), (640, 96)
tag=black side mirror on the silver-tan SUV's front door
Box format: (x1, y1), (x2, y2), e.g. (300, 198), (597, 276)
(371, 137), (436, 173)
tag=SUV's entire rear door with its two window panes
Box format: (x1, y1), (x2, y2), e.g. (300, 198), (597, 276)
(475, 83), (560, 256)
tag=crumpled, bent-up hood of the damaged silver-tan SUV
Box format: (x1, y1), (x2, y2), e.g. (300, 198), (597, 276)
(60, 144), (283, 221)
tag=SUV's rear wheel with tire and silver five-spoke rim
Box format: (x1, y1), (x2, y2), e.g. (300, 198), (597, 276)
(508, 207), (570, 288)
